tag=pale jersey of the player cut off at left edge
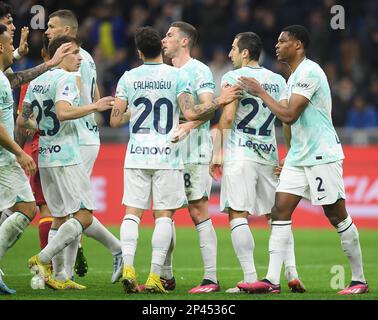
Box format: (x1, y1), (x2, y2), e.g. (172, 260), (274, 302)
(0, 71), (16, 166)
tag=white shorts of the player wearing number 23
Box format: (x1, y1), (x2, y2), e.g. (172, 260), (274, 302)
(39, 164), (96, 218)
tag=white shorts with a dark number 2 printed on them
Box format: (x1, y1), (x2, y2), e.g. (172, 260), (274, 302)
(277, 160), (345, 205)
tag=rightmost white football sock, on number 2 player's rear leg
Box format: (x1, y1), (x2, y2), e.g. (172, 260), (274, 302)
(336, 215), (366, 283)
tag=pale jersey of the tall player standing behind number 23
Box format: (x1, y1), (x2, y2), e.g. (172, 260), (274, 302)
(74, 48), (100, 146)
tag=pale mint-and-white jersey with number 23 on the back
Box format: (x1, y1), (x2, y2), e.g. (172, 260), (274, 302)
(24, 68), (82, 168)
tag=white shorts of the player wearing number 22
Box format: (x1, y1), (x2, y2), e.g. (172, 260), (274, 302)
(220, 161), (277, 216)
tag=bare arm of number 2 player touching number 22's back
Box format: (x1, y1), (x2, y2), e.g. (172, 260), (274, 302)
(239, 77), (309, 125)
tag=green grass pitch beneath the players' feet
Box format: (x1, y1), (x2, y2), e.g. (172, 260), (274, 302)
(0, 227), (378, 300)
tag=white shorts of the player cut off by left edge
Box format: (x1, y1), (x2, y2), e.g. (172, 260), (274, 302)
(0, 162), (35, 211)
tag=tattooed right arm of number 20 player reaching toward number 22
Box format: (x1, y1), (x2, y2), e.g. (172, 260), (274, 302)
(177, 86), (241, 121)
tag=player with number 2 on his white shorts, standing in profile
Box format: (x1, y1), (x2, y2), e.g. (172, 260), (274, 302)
(239, 25), (368, 294)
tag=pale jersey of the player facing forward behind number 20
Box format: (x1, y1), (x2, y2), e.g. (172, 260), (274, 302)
(180, 59), (215, 164)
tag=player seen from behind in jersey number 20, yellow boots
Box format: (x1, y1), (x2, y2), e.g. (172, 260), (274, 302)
(110, 27), (239, 293)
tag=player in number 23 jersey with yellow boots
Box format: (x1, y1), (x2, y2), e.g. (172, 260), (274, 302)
(19, 36), (114, 289)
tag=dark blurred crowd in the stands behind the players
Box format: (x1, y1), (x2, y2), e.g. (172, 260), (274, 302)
(7, 0), (378, 129)
